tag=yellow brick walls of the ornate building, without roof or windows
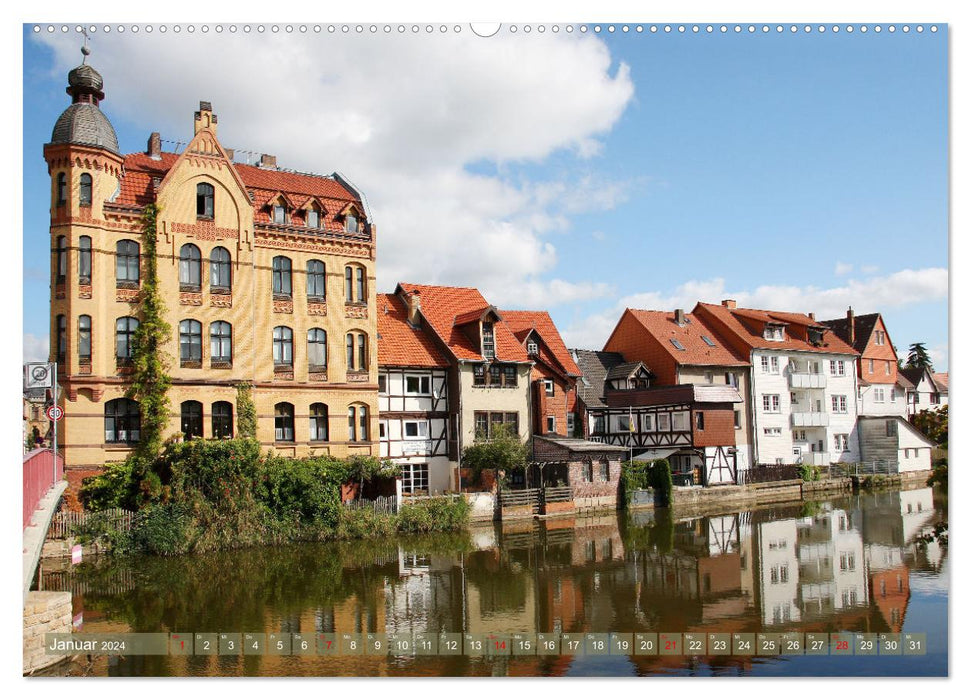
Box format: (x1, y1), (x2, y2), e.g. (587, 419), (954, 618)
(44, 104), (378, 466)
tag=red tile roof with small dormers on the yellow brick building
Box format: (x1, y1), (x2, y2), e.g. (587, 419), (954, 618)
(115, 153), (363, 231)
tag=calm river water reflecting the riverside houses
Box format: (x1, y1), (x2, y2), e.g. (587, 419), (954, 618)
(45, 488), (948, 676)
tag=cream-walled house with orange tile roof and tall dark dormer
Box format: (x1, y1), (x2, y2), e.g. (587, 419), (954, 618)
(395, 282), (533, 470)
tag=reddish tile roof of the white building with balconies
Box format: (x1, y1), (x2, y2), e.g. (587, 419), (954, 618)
(694, 302), (859, 355)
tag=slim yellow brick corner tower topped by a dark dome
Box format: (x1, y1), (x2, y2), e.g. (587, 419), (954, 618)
(44, 46), (123, 464)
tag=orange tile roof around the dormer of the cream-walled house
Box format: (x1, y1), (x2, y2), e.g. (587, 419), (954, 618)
(398, 282), (529, 362)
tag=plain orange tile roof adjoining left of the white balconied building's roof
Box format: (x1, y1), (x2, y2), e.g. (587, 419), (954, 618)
(620, 309), (749, 367)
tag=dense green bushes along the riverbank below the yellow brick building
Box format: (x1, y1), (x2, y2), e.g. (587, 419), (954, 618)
(78, 438), (469, 555)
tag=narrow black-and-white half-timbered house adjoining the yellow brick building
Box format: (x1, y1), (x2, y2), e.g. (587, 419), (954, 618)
(377, 294), (454, 495)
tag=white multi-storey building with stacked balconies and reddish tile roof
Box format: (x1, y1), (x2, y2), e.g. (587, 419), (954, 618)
(693, 300), (860, 465)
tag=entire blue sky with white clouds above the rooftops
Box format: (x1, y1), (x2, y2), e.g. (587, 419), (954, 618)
(24, 25), (948, 369)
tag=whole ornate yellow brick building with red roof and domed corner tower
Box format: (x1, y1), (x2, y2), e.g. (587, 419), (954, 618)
(44, 53), (378, 466)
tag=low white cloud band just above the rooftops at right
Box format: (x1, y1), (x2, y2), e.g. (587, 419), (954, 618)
(561, 267), (948, 348)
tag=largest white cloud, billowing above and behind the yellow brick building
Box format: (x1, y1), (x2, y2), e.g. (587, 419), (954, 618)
(34, 33), (634, 307)
